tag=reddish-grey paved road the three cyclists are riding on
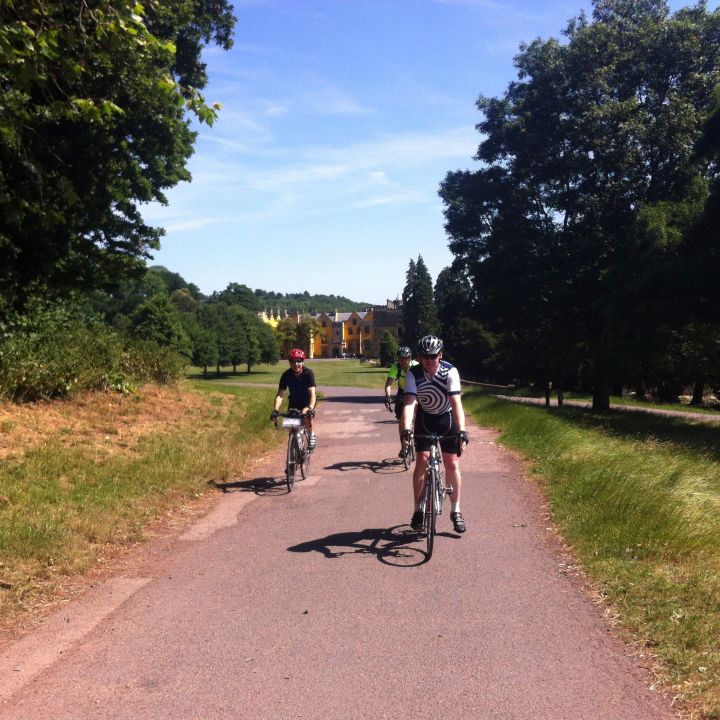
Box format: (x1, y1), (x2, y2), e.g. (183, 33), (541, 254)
(0, 388), (673, 720)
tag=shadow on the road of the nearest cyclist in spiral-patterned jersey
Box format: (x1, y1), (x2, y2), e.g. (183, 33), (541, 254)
(288, 525), (428, 567)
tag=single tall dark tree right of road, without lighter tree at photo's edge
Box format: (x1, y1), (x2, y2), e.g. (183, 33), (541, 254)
(441, 0), (720, 409)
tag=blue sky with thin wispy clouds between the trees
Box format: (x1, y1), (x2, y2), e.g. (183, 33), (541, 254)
(144, 0), (717, 304)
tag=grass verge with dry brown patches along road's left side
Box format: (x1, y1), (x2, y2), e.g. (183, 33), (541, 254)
(0, 382), (284, 628)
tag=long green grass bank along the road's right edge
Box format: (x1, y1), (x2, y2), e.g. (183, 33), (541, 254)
(465, 391), (720, 719)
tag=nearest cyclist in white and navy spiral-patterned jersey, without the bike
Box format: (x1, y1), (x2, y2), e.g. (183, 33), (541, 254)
(400, 335), (469, 533)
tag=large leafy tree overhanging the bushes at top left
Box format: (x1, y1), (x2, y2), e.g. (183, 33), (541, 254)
(0, 0), (234, 317)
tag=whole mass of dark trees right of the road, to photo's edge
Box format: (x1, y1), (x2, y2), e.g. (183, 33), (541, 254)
(430, 0), (720, 409)
